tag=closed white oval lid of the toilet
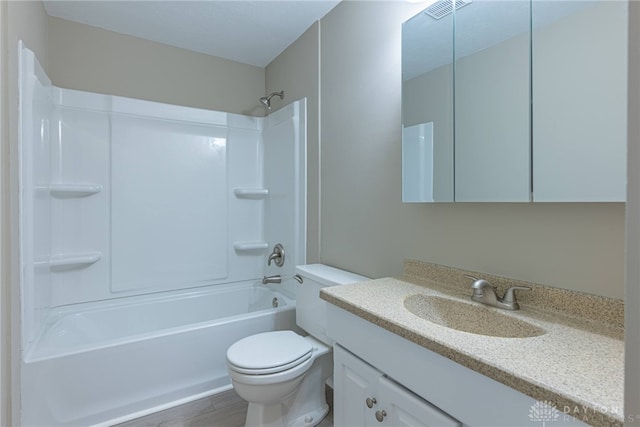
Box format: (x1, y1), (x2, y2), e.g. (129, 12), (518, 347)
(227, 331), (313, 373)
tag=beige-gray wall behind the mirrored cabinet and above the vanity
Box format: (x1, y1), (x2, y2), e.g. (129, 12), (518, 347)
(267, 1), (625, 298)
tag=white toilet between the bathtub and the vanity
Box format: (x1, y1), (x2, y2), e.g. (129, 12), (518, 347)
(227, 264), (369, 427)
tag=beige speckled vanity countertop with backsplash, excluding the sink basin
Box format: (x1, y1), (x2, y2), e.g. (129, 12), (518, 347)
(321, 260), (624, 426)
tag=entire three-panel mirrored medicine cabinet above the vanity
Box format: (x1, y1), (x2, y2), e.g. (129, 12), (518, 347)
(402, 0), (628, 202)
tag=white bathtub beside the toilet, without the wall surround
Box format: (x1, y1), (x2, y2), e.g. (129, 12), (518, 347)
(22, 282), (295, 426)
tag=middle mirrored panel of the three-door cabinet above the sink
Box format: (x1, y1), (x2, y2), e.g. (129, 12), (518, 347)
(454, 0), (531, 202)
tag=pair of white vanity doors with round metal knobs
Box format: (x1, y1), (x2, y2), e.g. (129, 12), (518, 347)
(334, 345), (462, 427)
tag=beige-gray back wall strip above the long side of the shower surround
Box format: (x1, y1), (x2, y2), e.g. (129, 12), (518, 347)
(49, 17), (264, 116)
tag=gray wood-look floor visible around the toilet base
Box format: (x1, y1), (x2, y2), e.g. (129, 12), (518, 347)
(114, 389), (333, 427)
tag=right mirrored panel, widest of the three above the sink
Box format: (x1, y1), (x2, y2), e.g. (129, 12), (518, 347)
(532, 0), (628, 202)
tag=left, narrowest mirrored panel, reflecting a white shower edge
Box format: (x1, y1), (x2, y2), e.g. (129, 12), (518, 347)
(402, 4), (454, 202)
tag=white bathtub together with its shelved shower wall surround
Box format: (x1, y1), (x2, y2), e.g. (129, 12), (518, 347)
(16, 47), (306, 426)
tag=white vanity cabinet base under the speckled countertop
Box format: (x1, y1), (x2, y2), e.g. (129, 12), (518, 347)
(327, 304), (586, 427)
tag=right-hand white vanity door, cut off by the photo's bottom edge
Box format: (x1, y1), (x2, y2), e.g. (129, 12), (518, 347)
(376, 377), (462, 427)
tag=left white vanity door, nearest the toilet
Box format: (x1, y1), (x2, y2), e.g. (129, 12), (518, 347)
(333, 345), (382, 427)
